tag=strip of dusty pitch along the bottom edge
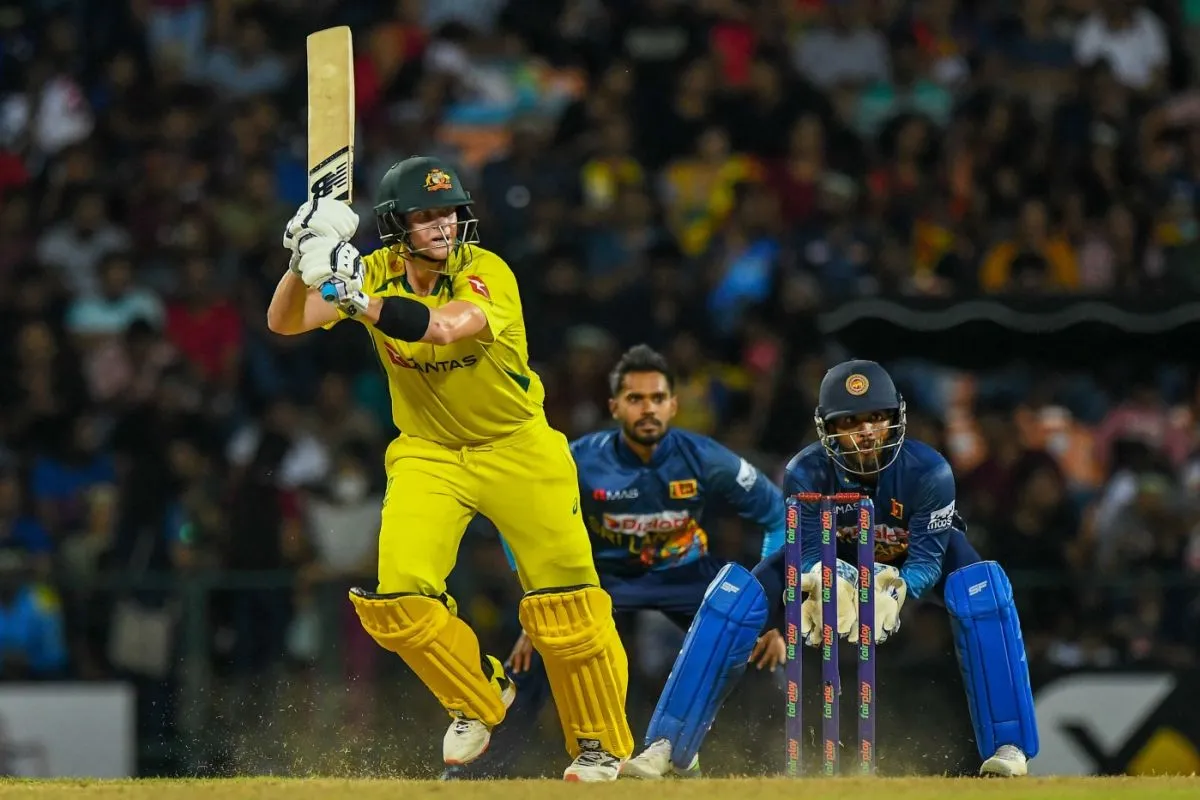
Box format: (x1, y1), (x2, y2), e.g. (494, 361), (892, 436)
(0, 777), (1200, 800)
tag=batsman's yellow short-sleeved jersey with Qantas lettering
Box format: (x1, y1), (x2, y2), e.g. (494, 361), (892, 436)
(326, 245), (546, 447)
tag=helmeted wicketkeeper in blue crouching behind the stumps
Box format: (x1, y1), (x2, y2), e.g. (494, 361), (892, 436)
(622, 361), (1038, 777)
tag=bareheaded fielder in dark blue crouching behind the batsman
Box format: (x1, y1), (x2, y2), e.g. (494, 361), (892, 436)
(443, 345), (786, 780)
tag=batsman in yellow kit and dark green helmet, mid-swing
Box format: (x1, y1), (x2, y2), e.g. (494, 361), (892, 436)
(268, 157), (634, 781)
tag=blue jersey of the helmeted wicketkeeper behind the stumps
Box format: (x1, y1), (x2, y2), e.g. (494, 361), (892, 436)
(784, 439), (966, 599)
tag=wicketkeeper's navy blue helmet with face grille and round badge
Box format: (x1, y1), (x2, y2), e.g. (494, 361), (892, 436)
(815, 360), (908, 475)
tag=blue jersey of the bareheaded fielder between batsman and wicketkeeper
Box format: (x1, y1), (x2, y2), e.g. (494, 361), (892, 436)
(571, 429), (785, 575)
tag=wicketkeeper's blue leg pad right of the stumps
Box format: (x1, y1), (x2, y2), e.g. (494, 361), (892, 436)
(946, 561), (1038, 759)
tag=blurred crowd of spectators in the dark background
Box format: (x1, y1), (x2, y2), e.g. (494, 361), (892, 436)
(0, 0), (1200, 743)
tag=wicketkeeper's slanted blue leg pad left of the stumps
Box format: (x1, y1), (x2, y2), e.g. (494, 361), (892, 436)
(646, 564), (768, 769)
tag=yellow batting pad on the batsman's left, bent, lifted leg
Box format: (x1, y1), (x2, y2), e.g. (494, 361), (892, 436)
(350, 589), (504, 727)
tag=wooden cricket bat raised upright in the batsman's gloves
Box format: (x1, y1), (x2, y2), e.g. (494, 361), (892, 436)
(307, 25), (354, 301)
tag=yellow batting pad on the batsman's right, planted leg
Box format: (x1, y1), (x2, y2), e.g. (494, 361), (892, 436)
(521, 587), (634, 758)
